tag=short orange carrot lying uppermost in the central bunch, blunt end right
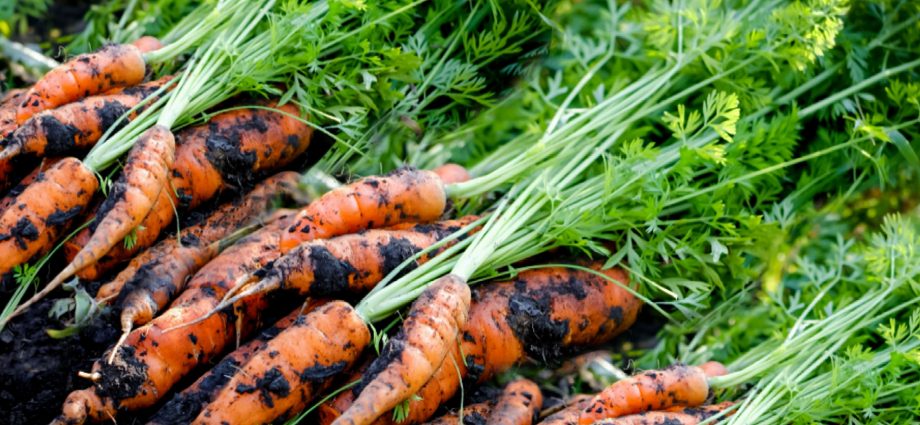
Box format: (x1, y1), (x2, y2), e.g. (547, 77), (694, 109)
(281, 168), (447, 252)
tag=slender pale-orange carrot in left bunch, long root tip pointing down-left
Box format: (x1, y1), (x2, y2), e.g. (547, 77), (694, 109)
(37, 125), (176, 296)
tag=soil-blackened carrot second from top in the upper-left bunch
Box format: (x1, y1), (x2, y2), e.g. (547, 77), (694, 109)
(0, 77), (171, 179)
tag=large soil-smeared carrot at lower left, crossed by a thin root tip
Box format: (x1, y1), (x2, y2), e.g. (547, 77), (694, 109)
(58, 218), (290, 424)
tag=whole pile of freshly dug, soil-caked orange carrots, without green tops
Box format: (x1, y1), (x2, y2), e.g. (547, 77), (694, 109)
(0, 29), (744, 425)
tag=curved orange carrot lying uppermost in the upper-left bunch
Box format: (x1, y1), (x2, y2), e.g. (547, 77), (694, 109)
(16, 44), (147, 125)
